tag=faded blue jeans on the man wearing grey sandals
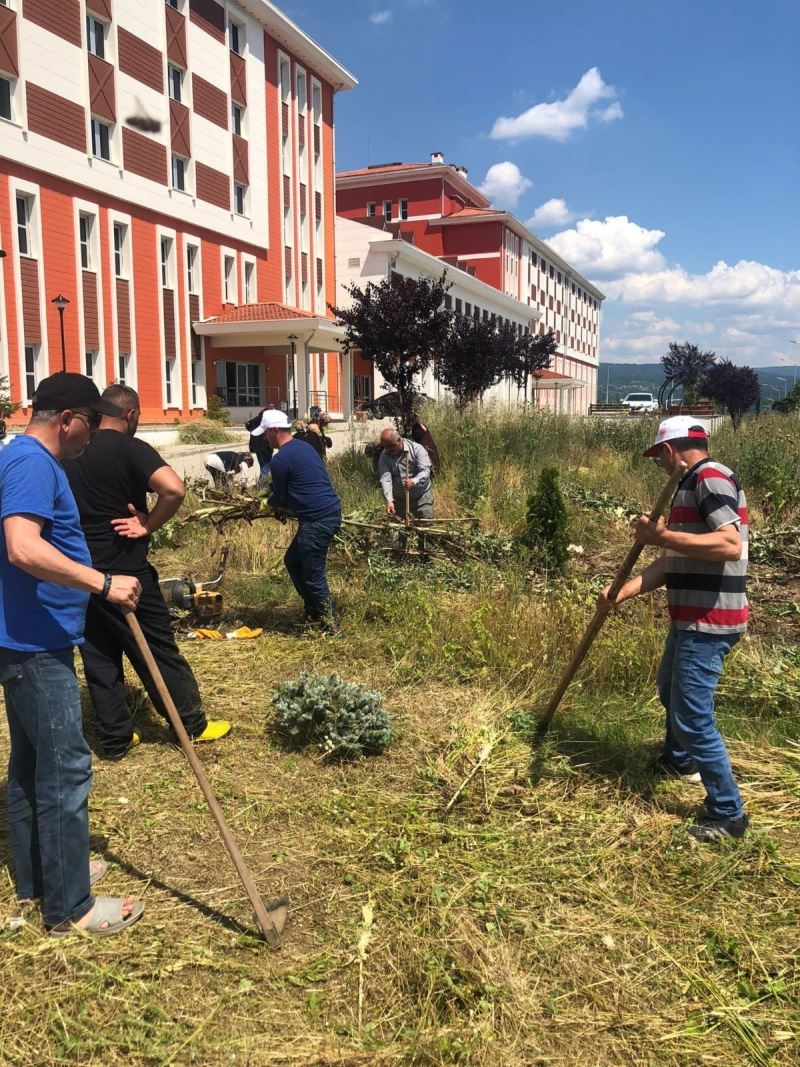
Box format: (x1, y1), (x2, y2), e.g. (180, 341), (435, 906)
(0, 648), (94, 926)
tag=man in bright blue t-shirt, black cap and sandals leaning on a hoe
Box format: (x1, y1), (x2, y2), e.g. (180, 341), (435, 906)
(0, 372), (144, 937)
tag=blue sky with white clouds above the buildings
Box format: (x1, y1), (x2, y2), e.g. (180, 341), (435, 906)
(278, 0), (800, 373)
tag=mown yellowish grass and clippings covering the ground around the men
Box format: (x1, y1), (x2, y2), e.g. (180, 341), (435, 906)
(0, 403), (800, 1067)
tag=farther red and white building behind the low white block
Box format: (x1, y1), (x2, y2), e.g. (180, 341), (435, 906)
(336, 153), (605, 415)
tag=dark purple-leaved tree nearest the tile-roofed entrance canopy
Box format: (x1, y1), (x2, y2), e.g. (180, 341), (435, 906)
(329, 271), (450, 434)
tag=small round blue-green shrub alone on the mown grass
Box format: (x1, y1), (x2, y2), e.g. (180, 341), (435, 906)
(272, 671), (393, 760)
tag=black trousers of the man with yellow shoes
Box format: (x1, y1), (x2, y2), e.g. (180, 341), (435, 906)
(80, 566), (206, 758)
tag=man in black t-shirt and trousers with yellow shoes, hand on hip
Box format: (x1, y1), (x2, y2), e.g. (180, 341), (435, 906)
(66, 385), (230, 760)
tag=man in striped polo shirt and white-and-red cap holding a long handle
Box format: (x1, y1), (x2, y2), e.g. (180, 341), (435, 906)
(601, 415), (749, 843)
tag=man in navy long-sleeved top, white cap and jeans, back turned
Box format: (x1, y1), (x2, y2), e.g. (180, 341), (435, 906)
(261, 411), (341, 634)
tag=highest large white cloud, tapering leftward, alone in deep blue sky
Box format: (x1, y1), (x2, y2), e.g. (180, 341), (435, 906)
(490, 67), (623, 141)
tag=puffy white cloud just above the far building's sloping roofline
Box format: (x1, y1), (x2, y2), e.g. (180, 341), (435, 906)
(547, 214), (665, 275)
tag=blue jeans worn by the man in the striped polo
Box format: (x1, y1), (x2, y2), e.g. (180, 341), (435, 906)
(658, 626), (745, 818)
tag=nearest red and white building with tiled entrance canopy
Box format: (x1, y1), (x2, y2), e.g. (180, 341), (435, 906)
(0, 0), (356, 423)
